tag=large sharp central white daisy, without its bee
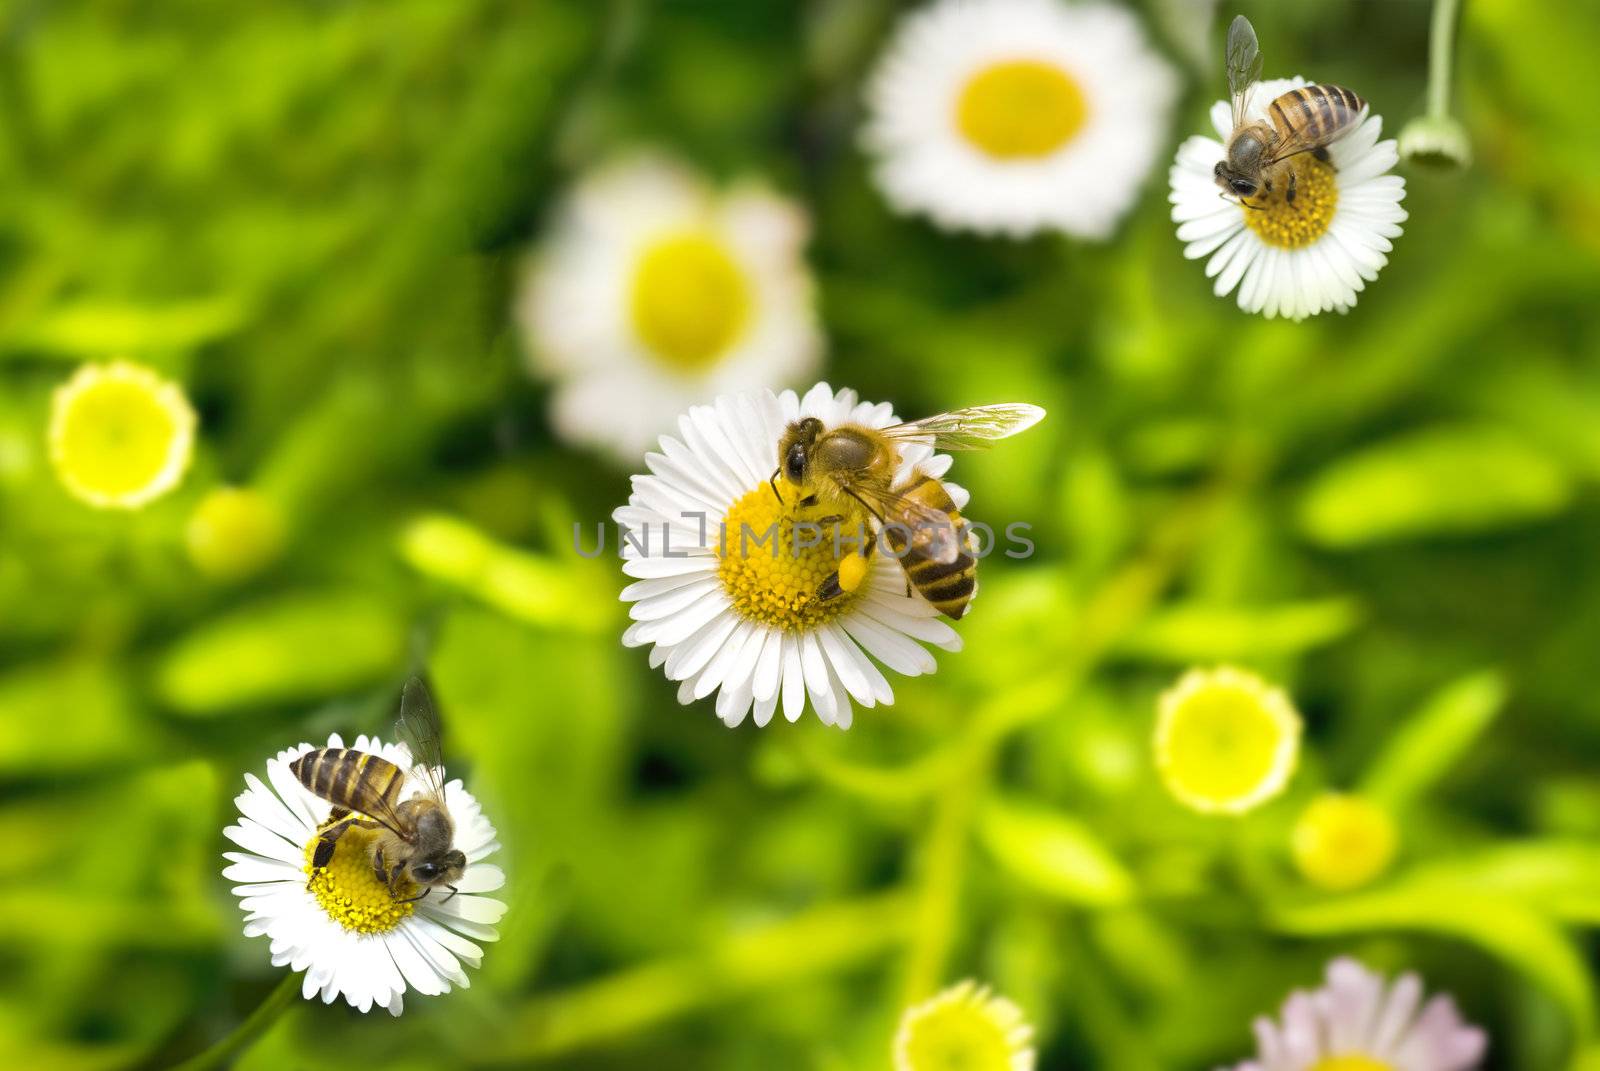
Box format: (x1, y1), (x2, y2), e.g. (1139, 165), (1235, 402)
(613, 383), (966, 728)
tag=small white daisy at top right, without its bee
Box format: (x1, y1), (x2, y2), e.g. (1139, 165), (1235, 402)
(1170, 77), (1406, 320)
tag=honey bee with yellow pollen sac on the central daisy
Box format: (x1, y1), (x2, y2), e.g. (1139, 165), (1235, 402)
(768, 403), (1045, 620)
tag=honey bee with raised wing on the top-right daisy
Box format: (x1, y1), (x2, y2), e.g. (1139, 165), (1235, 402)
(1214, 14), (1366, 208)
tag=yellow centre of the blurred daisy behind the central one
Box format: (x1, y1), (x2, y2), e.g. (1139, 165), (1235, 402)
(630, 234), (752, 371)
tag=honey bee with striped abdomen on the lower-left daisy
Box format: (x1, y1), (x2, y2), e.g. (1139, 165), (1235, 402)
(290, 677), (467, 903)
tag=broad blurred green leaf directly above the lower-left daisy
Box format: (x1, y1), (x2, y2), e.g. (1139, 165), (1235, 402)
(155, 592), (406, 714)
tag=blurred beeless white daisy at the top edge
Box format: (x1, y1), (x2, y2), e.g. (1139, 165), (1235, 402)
(862, 0), (1178, 239)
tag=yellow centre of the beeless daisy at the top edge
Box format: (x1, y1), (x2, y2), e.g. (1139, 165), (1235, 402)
(955, 59), (1088, 160)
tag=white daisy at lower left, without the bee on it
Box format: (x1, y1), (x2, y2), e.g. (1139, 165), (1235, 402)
(222, 735), (506, 1015)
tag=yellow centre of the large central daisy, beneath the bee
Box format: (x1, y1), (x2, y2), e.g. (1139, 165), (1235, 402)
(717, 480), (872, 632)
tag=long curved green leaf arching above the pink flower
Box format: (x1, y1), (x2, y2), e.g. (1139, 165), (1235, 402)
(1270, 880), (1595, 1041)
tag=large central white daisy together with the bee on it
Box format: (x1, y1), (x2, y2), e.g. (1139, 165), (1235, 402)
(613, 383), (1043, 728)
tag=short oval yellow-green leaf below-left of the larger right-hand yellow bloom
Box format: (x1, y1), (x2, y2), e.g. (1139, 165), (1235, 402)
(979, 800), (1134, 908)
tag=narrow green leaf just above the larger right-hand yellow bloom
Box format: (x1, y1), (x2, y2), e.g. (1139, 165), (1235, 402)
(1117, 599), (1360, 664)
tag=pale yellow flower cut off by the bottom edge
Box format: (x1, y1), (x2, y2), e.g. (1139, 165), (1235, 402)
(894, 980), (1034, 1071)
